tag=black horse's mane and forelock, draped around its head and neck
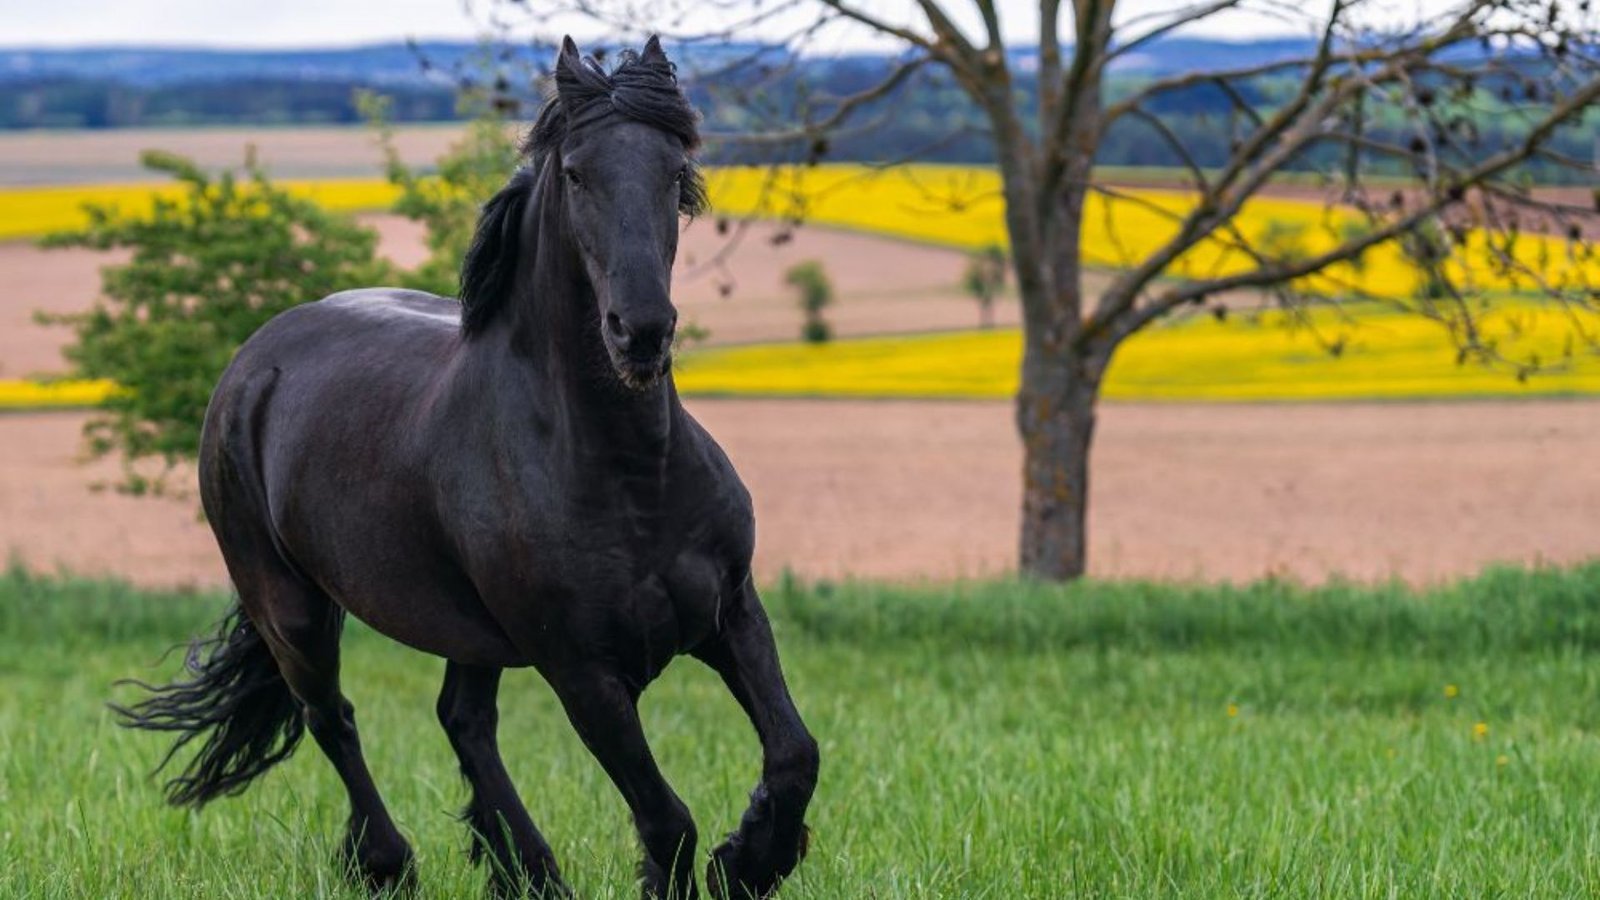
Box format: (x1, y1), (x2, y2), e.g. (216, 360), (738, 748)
(461, 38), (709, 335)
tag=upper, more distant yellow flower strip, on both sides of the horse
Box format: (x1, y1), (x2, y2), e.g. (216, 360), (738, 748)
(0, 165), (1600, 296)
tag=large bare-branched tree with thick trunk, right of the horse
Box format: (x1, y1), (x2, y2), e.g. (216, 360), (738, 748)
(492, 0), (1600, 580)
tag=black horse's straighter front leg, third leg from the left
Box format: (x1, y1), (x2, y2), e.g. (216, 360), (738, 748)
(550, 666), (699, 900)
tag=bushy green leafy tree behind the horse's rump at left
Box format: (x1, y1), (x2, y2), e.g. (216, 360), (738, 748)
(43, 152), (389, 493)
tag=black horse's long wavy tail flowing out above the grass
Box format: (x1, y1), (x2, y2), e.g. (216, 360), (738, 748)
(112, 604), (306, 809)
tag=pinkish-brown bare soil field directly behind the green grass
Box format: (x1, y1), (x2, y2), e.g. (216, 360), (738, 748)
(0, 400), (1600, 585)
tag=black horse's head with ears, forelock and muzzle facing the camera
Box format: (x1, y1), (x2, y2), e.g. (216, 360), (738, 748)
(462, 37), (706, 388)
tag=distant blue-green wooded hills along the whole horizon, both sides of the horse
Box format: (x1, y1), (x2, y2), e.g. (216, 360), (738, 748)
(0, 56), (1600, 183)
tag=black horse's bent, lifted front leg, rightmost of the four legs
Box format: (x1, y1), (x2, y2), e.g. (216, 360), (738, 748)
(694, 580), (819, 900)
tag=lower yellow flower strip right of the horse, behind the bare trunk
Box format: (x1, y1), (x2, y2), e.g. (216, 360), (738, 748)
(677, 301), (1600, 400)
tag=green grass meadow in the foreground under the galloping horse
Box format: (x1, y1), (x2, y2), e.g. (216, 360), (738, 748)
(0, 564), (1600, 900)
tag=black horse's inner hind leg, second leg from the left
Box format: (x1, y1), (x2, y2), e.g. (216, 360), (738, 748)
(438, 661), (566, 897)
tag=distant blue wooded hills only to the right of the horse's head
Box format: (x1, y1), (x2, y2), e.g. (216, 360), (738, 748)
(691, 58), (1600, 183)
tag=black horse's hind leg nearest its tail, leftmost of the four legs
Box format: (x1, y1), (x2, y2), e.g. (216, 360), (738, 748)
(240, 572), (414, 890)
